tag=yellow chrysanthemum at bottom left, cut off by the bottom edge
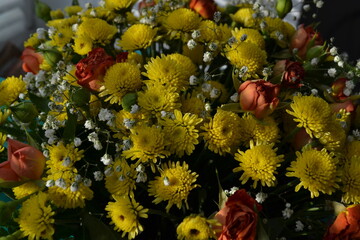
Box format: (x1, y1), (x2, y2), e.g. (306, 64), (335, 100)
(17, 192), (55, 240)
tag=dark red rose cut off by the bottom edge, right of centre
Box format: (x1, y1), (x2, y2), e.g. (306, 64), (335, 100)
(215, 189), (262, 240)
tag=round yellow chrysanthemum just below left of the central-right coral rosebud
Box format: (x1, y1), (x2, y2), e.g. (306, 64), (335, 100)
(201, 108), (241, 155)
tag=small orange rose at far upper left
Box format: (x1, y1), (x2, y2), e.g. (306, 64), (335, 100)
(21, 47), (44, 74)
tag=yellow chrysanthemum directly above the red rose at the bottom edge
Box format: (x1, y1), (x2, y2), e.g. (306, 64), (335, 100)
(233, 141), (284, 188)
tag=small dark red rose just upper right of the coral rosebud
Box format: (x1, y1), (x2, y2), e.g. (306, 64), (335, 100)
(274, 60), (305, 88)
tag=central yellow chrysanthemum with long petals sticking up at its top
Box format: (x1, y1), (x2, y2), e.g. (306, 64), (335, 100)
(160, 110), (202, 157)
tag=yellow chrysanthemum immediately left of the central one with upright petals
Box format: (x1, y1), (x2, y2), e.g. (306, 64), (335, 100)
(123, 125), (169, 163)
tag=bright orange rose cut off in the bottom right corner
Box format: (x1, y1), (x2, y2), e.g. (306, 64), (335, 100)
(324, 205), (360, 240)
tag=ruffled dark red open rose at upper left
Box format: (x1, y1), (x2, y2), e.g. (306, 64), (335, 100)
(75, 48), (115, 91)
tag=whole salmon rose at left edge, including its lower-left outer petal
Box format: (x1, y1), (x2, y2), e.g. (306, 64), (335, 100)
(0, 139), (46, 186)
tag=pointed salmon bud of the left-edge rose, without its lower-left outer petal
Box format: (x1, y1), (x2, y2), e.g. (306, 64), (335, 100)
(7, 139), (46, 180)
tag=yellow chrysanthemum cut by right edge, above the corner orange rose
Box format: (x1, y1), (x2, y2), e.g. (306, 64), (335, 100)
(341, 155), (360, 204)
